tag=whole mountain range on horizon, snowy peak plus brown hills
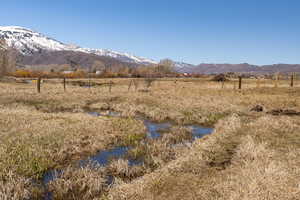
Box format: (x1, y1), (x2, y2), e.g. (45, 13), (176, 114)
(0, 26), (300, 74)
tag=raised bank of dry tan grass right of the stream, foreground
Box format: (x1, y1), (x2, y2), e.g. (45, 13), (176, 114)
(108, 116), (300, 200)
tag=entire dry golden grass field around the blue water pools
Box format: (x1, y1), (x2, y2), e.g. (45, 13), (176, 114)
(0, 79), (300, 200)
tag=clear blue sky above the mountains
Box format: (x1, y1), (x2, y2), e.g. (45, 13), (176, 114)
(0, 0), (300, 64)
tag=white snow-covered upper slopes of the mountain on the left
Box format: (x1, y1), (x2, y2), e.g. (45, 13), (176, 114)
(0, 26), (156, 64)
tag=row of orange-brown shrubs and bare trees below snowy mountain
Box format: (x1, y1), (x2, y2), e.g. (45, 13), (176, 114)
(10, 59), (177, 78)
